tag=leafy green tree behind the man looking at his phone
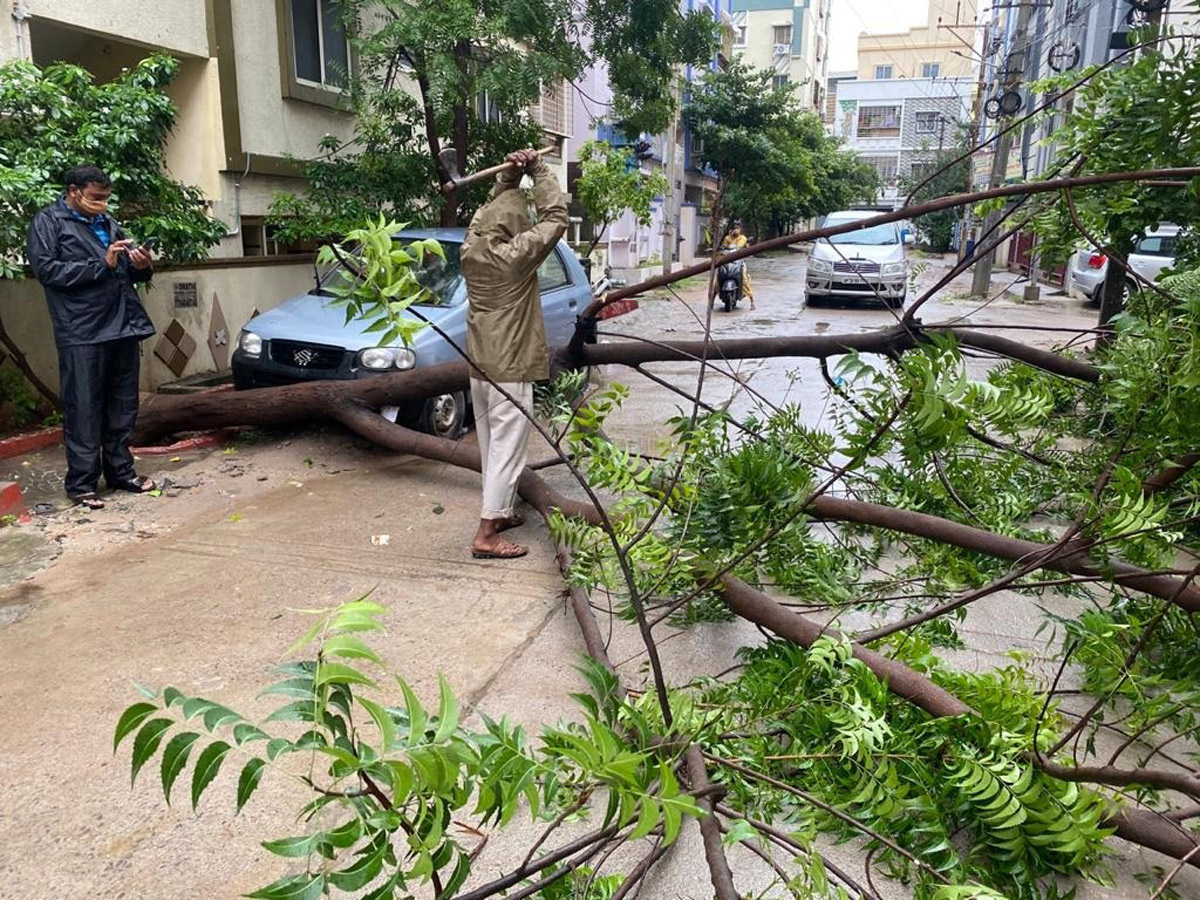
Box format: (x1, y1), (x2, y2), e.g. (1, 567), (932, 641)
(0, 56), (224, 277)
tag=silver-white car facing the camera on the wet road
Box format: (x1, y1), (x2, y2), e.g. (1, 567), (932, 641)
(805, 210), (908, 310)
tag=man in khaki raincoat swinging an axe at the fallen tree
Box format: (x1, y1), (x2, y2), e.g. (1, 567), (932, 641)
(461, 150), (566, 559)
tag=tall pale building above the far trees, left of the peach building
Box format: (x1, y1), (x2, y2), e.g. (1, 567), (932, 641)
(731, 0), (832, 113)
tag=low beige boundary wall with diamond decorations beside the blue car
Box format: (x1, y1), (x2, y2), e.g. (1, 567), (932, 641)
(0, 256), (312, 391)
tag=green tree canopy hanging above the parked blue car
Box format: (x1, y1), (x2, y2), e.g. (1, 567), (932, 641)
(274, 0), (716, 238)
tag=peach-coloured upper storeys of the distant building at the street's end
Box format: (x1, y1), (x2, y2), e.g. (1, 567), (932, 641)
(858, 0), (976, 82)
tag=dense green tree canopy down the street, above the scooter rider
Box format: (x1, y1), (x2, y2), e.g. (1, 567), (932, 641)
(688, 61), (877, 232)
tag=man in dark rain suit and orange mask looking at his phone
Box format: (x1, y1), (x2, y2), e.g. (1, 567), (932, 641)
(26, 166), (155, 509)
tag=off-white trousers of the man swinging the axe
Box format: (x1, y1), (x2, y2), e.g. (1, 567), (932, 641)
(470, 378), (533, 518)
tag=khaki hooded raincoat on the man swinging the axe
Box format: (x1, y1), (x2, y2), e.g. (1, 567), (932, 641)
(461, 158), (566, 382)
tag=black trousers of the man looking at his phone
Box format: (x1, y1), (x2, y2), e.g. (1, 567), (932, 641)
(59, 337), (140, 497)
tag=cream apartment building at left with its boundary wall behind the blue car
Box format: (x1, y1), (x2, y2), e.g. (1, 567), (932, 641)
(0, 0), (571, 390)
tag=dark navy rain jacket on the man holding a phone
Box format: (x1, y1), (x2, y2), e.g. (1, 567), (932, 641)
(26, 200), (155, 347)
